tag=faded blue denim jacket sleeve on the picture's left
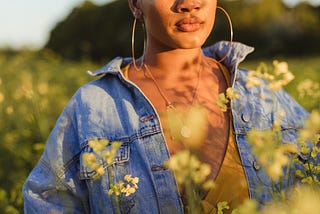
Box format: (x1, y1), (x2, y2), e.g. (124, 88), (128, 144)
(23, 96), (88, 214)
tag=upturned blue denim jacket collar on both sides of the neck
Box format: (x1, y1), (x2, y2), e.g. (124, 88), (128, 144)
(88, 41), (254, 79)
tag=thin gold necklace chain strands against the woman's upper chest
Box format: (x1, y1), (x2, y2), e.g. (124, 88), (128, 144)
(143, 64), (203, 109)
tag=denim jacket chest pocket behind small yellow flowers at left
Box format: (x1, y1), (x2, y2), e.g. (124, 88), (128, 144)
(80, 142), (130, 186)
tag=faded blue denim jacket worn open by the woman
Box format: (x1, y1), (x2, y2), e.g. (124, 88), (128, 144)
(23, 42), (308, 214)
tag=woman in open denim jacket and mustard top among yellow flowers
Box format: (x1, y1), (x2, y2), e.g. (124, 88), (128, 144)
(23, 0), (307, 213)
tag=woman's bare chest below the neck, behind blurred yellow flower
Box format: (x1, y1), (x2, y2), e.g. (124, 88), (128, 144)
(127, 65), (230, 178)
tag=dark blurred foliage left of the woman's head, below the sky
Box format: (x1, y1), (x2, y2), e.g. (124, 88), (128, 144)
(46, 0), (139, 61)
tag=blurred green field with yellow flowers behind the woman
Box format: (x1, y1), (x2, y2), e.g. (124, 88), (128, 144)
(0, 51), (320, 214)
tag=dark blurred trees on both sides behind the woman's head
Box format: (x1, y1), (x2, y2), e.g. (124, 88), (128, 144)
(45, 0), (320, 61)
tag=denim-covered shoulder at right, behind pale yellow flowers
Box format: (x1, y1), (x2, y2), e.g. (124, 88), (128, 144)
(233, 69), (309, 129)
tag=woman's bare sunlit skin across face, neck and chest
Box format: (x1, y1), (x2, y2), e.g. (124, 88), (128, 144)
(129, 0), (230, 182)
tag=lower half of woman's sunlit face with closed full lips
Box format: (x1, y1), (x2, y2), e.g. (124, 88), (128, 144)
(138, 0), (217, 49)
